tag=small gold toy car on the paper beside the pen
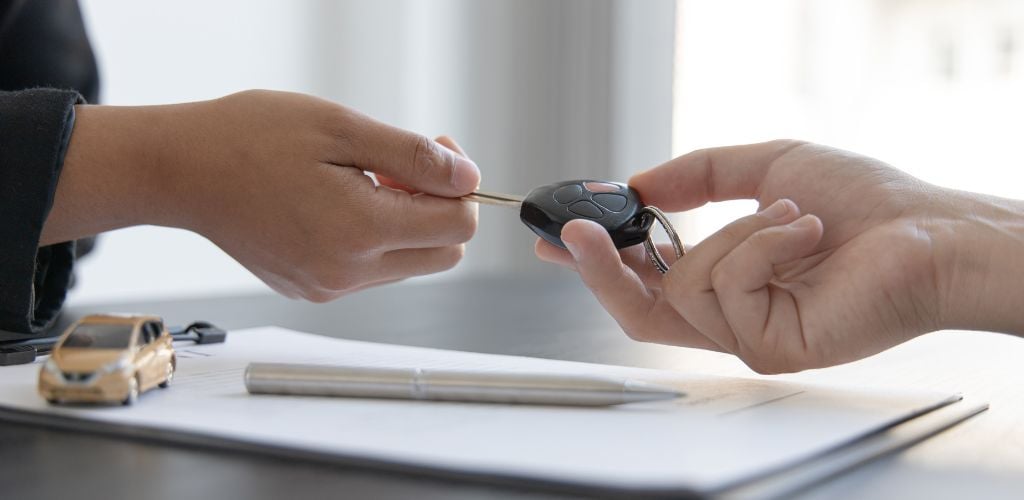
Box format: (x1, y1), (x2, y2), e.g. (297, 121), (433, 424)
(39, 315), (175, 405)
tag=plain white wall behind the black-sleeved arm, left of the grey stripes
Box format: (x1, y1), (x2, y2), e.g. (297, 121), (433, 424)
(69, 0), (314, 303)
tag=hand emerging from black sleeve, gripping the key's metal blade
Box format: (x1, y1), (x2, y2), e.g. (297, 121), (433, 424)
(44, 91), (480, 301)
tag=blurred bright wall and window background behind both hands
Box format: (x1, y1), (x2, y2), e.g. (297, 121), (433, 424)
(70, 0), (1024, 304)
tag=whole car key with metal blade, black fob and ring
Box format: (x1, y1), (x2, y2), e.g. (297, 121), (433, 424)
(463, 179), (683, 273)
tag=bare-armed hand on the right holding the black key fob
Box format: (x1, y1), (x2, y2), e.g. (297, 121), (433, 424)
(537, 141), (1024, 373)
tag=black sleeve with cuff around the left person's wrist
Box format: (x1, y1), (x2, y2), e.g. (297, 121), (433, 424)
(0, 89), (82, 334)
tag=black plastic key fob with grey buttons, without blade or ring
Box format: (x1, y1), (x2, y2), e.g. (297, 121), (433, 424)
(519, 180), (654, 248)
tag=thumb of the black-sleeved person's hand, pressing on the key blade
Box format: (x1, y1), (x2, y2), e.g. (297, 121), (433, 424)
(349, 121), (480, 198)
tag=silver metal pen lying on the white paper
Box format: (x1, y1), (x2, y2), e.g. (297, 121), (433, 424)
(245, 363), (684, 407)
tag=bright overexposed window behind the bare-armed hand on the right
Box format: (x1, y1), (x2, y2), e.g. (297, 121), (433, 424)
(673, 0), (1024, 241)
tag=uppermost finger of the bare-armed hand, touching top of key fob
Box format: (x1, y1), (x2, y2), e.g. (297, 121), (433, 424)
(629, 140), (804, 212)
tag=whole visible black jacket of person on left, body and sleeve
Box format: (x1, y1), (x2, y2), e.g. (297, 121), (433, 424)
(0, 0), (99, 340)
